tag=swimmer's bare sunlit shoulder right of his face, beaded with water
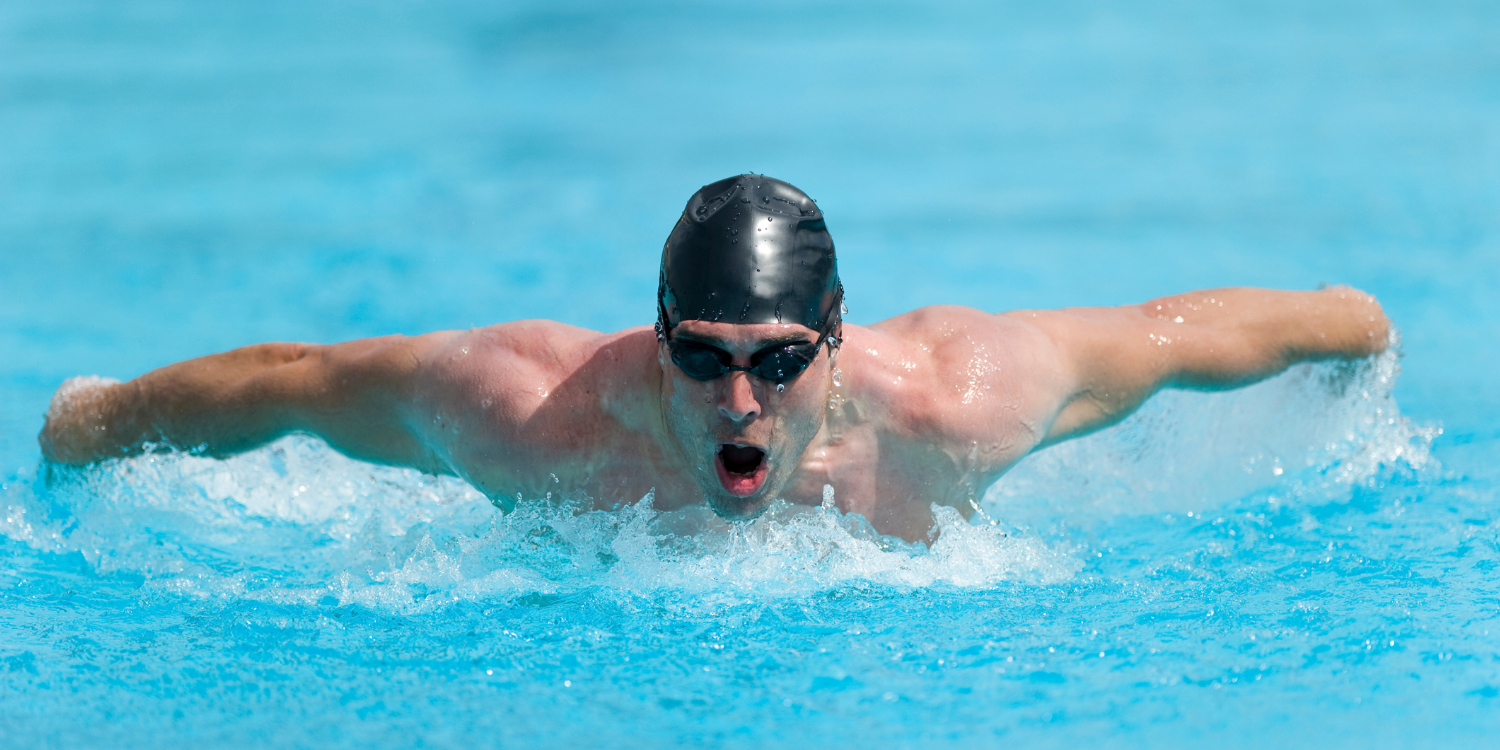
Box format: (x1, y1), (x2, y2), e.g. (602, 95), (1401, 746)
(840, 306), (1062, 458)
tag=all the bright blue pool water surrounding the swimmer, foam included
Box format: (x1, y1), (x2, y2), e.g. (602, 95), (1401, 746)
(0, 0), (1500, 749)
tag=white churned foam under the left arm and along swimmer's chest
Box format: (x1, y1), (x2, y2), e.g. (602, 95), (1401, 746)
(0, 437), (1077, 612)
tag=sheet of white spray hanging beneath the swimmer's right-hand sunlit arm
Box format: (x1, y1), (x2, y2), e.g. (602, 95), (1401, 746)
(981, 335), (1442, 528)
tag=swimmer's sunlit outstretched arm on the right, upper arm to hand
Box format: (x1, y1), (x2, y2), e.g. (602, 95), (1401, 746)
(1026, 287), (1389, 446)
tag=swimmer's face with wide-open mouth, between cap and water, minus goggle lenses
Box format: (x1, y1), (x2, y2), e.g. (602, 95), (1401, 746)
(657, 321), (831, 519)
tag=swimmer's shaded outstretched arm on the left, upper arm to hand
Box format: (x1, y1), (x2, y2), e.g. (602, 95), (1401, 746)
(39, 333), (458, 473)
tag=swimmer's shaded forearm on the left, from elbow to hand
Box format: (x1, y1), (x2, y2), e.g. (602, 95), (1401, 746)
(39, 344), (311, 464)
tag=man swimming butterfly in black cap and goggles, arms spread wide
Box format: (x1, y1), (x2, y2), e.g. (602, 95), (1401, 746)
(39, 174), (1389, 540)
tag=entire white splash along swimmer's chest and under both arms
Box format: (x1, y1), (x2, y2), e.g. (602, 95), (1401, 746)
(0, 343), (1436, 611)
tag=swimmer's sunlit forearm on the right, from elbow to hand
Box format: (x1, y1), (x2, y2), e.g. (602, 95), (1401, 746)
(1140, 287), (1389, 389)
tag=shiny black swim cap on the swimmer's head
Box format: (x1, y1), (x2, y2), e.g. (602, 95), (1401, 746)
(657, 174), (843, 339)
